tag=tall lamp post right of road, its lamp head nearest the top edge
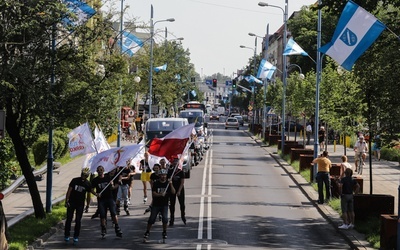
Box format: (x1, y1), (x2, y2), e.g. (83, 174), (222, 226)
(258, 0), (289, 152)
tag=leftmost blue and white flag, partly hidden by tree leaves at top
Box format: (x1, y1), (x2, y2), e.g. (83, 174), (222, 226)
(62, 0), (96, 27)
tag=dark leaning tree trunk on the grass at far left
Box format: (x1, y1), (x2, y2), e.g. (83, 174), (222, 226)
(6, 105), (46, 219)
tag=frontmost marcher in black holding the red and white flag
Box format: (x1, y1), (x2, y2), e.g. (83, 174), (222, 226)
(143, 169), (175, 242)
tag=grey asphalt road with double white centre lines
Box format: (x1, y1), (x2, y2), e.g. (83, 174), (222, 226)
(43, 122), (349, 250)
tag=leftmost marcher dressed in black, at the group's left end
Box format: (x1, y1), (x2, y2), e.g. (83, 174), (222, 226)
(64, 169), (92, 242)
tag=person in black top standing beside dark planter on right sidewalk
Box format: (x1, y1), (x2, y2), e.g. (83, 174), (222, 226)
(339, 168), (360, 229)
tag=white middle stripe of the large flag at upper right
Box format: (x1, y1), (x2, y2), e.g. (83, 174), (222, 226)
(326, 7), (377, 64)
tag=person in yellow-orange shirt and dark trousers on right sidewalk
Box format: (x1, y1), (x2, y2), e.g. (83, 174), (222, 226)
(313, 151), (332, 204)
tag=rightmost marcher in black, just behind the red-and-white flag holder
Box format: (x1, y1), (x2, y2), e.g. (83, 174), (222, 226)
(168, 159), (186, 226)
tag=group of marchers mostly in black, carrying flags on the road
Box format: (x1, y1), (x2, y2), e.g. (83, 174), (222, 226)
(64, 152), (186, 243)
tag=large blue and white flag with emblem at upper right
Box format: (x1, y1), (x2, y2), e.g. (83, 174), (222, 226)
(318, 1), (386, 71)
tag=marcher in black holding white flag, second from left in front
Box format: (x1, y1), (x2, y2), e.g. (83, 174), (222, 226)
(92, 166), (122, 238)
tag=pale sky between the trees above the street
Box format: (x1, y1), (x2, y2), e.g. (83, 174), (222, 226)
(108, 0), (316, 77)
